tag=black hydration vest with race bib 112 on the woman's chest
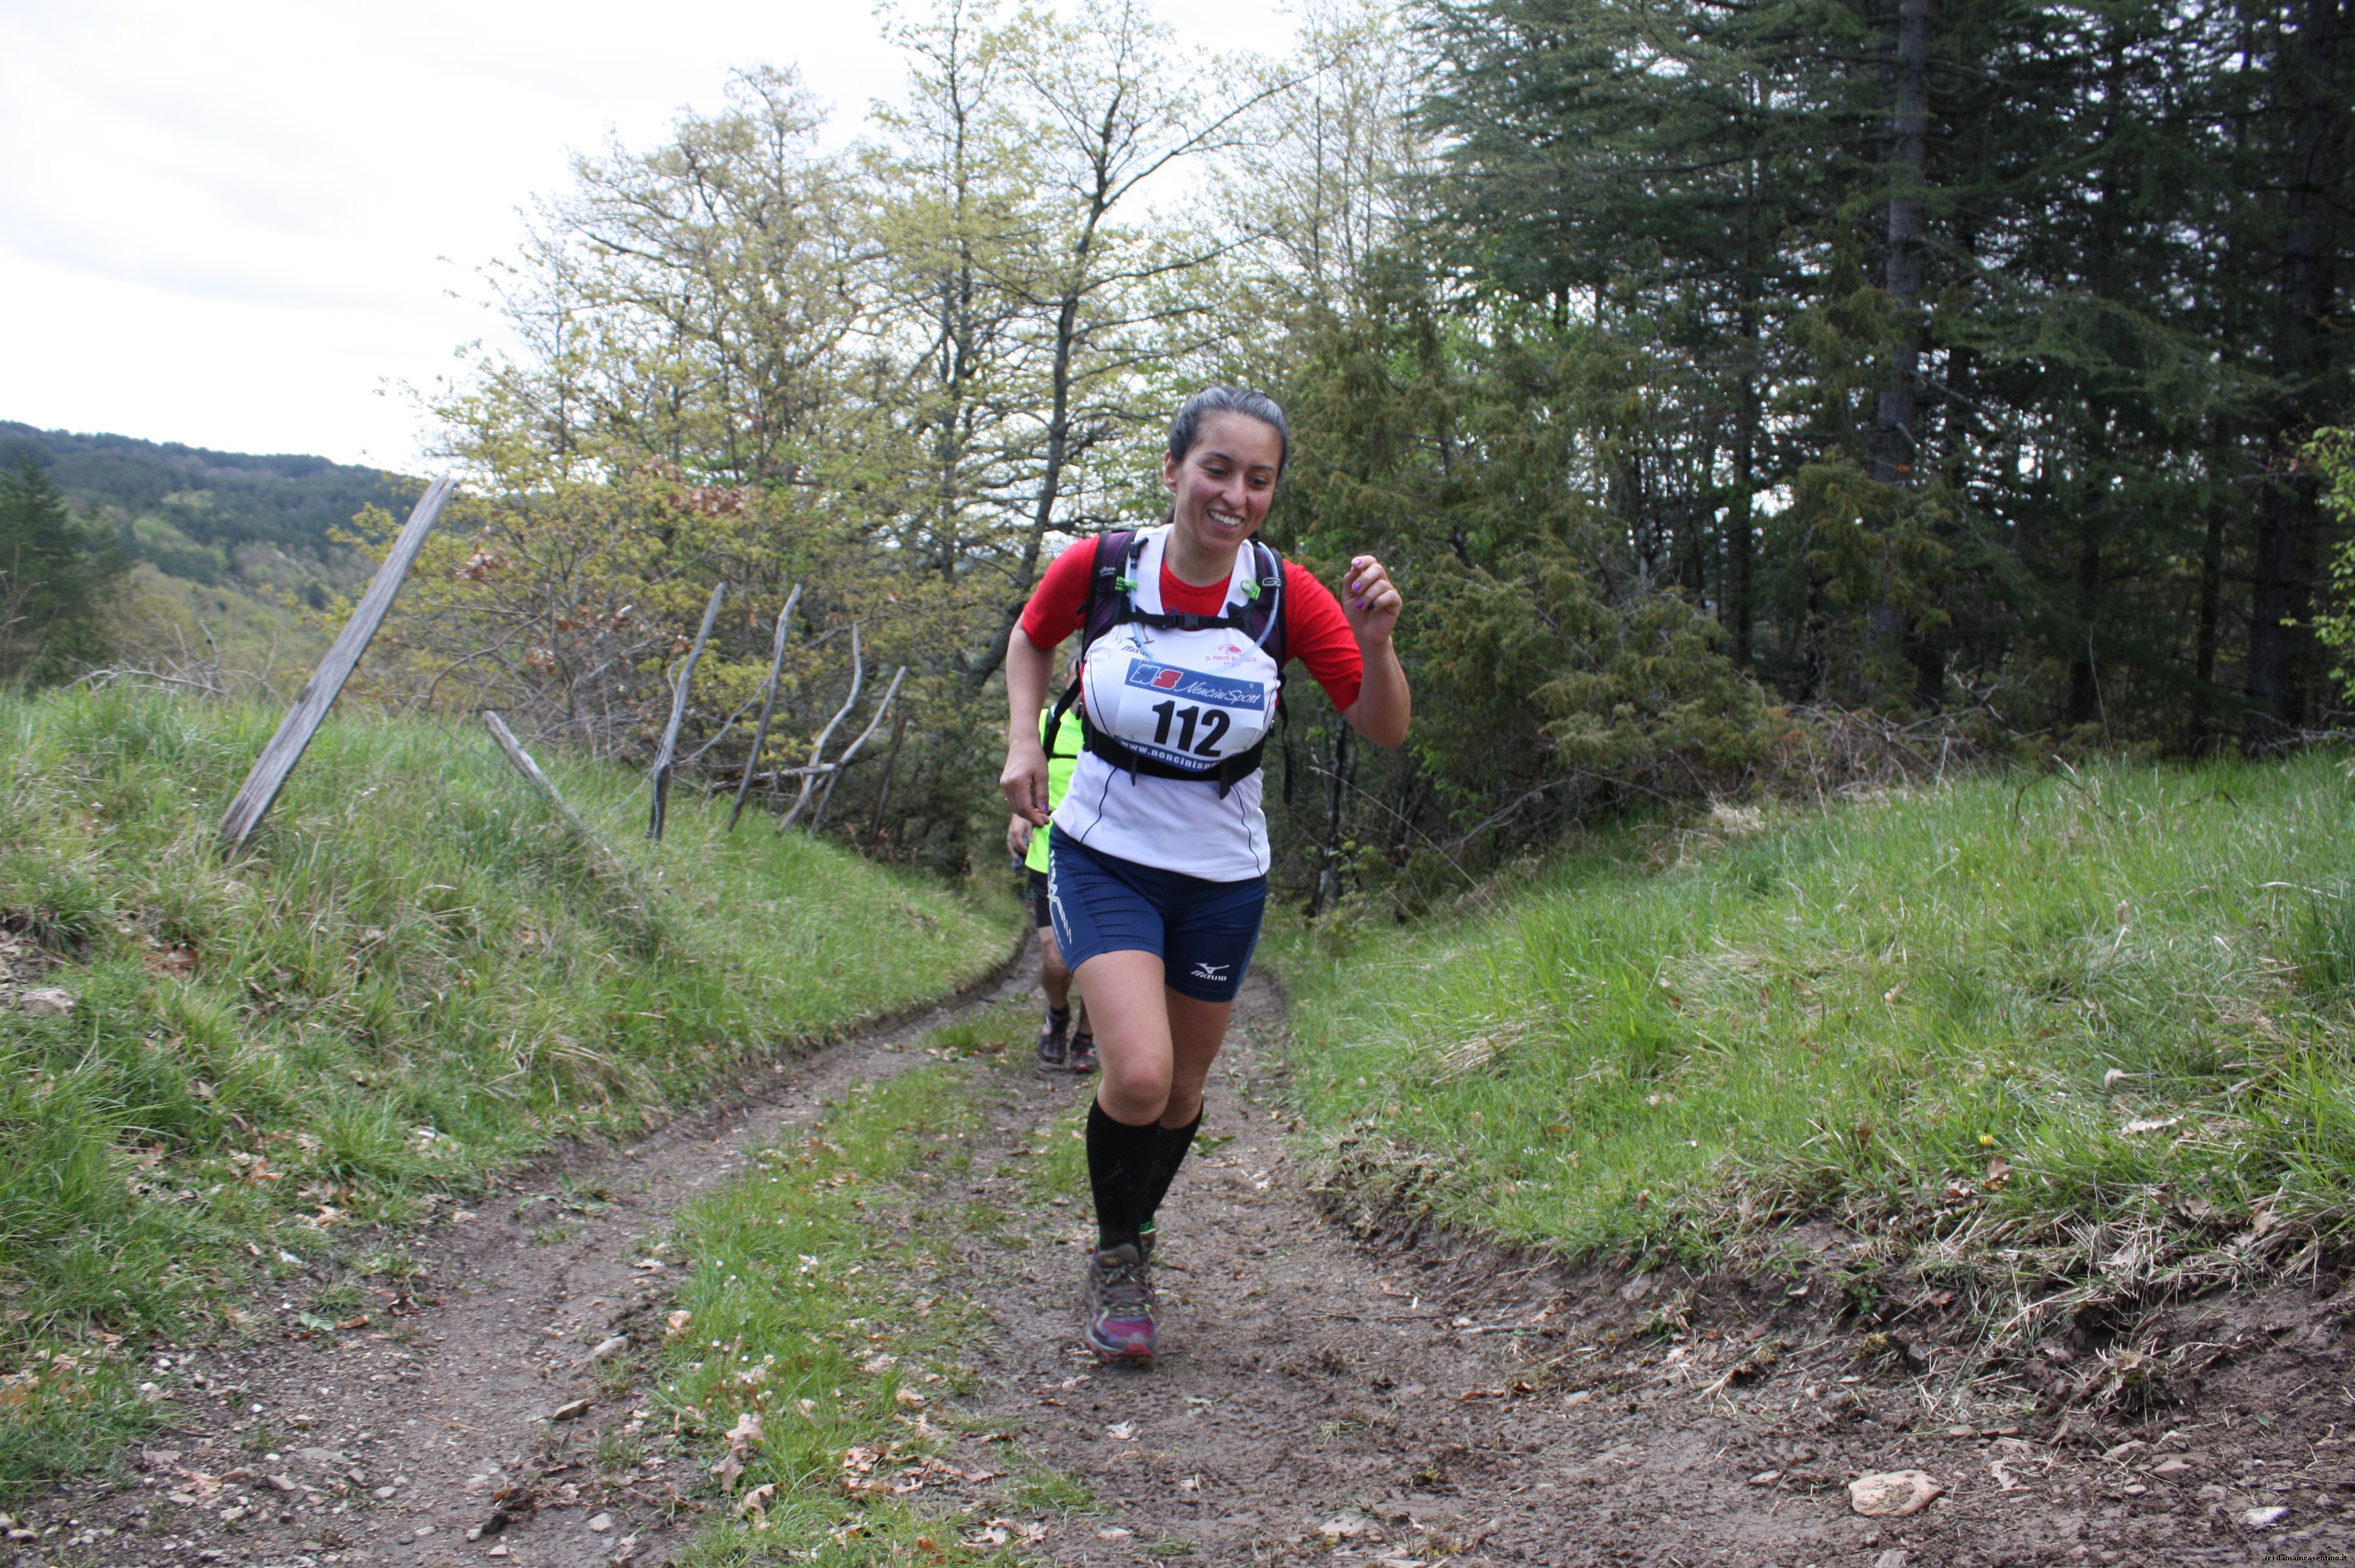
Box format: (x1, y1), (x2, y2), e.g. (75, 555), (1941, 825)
(1055, 528), (1284, 798)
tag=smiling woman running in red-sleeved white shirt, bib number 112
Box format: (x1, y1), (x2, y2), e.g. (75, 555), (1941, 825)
(998, 386), (1413, 1361)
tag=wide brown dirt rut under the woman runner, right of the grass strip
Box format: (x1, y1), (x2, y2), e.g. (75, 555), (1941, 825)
(965, 979), (2355, 1568)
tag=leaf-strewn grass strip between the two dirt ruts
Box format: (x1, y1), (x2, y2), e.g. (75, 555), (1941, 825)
(650, 1020), (1046, 1568)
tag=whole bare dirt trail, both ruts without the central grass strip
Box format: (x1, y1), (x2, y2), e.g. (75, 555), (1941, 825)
(17, 941), (2355, 1568)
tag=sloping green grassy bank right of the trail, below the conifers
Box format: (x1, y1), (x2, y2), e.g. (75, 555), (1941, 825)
(1272, 753), (2355, 1330)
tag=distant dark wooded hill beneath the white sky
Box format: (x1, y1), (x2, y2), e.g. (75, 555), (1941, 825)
(0, 419), (424, 607)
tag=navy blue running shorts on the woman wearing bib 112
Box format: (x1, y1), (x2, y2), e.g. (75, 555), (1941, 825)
(1048, 834), (1267, 1003)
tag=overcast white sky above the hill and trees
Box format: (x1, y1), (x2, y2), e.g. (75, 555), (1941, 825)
(0, 0), (1290, 468)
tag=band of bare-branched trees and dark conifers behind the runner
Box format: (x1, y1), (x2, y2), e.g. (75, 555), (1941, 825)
(336, 0), (2355, 892)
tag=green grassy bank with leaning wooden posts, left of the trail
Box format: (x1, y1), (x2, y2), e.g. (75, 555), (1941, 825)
(0, 692), (1015, 1488)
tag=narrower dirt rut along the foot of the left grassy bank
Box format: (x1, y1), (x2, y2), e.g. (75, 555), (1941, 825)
(17, 958), (1034, 1568)
